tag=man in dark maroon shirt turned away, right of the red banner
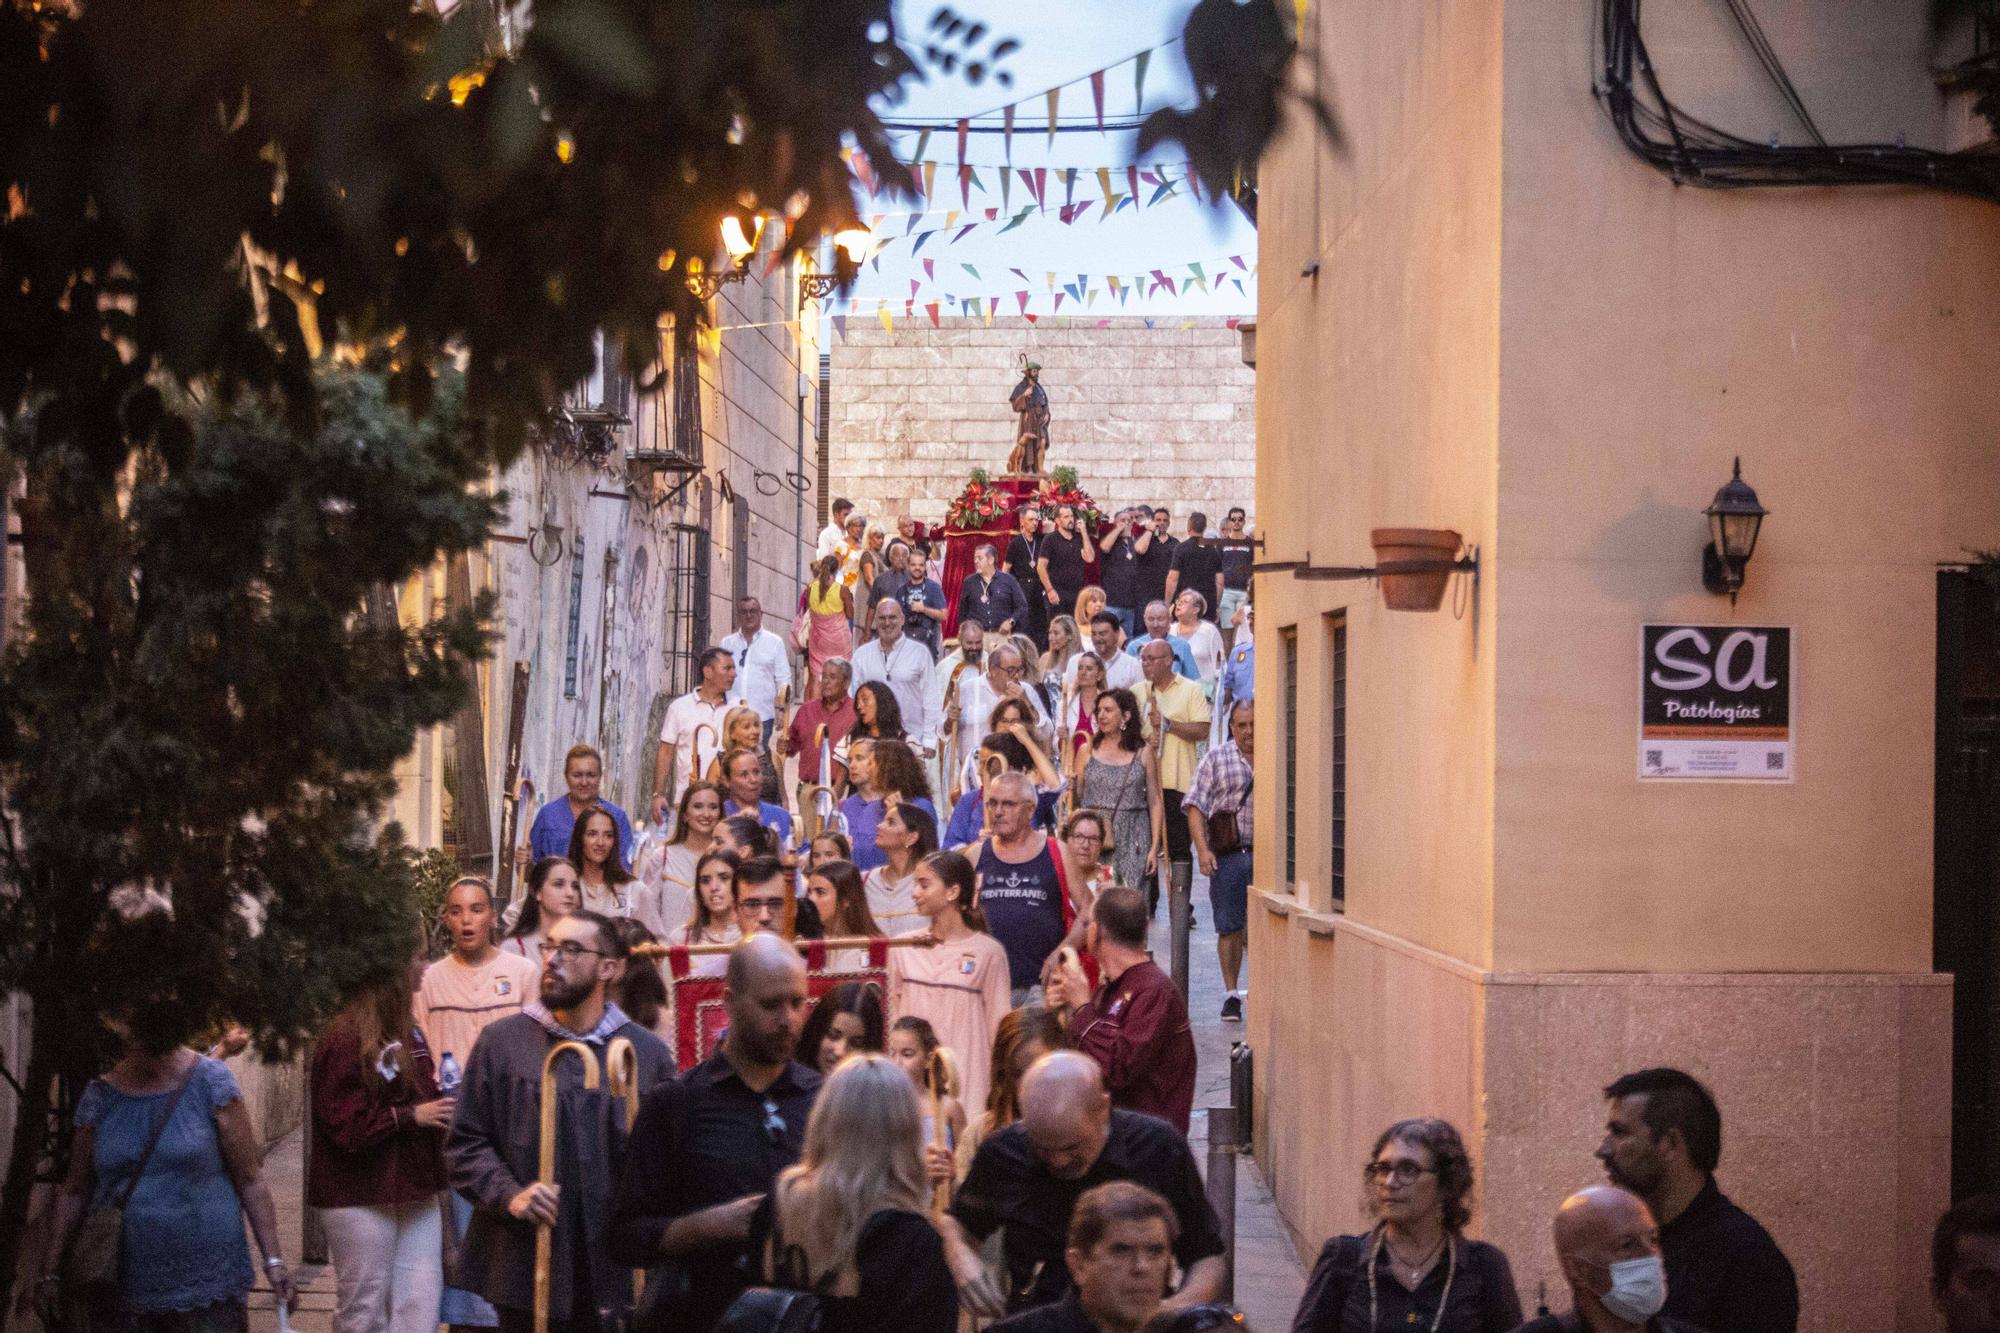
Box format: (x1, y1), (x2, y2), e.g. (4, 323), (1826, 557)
(1046, 885), (1194, 1135)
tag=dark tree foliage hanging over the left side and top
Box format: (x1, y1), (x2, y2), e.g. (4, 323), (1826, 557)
(0, 0), (1328, 1271)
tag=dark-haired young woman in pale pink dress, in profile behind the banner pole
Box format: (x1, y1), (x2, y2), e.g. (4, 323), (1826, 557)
(888, 853), (1014, 1107)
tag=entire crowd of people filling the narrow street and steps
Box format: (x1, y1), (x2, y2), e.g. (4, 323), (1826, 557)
(31, 488), (2000, 1333)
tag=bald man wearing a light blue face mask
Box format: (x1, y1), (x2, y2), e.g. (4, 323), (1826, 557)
(1514, 1185), (1702, 1333)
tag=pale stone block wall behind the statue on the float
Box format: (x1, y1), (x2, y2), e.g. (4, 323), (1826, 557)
(828, 316), (1256, 532)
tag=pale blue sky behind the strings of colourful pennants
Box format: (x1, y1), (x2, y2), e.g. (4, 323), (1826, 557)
(830, 0), (1256, 320)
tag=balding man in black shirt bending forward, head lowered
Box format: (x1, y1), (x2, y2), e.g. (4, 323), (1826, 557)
(938, 1051), (1226, 1317)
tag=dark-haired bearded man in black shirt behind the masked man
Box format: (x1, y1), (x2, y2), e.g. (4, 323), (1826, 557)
(1598, 1069), (1798, 1333)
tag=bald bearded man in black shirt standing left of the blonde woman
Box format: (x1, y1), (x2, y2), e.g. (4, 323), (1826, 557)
(612, 933), (820, 1329)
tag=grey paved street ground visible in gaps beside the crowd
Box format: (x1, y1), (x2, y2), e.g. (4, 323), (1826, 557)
(250, 881), (1306, 1333)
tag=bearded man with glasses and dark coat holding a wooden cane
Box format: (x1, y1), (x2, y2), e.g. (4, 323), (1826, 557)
(444, 913), (674, 1333)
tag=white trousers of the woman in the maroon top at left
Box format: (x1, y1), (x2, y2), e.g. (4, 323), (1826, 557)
(320, 1199), (444, 1333)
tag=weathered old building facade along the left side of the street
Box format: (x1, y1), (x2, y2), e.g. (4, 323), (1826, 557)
(396, 262), (820, 865)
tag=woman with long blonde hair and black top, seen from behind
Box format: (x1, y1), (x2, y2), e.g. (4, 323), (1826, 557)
(750, 1053), (958, 1333)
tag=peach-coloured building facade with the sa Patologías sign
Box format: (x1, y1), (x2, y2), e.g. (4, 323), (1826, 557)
(1248, 0), (2000, 1329)
